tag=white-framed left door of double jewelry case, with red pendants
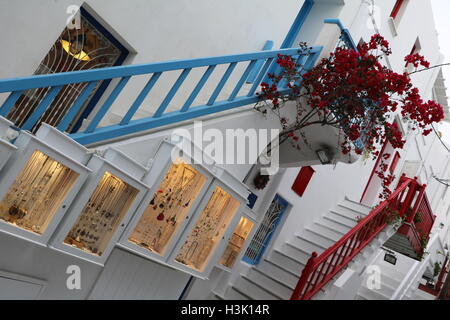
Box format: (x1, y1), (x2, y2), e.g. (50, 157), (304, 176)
(120, 157), (212, 261)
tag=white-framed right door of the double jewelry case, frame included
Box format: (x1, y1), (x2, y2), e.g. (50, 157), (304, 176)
(168, 179), (245, 278)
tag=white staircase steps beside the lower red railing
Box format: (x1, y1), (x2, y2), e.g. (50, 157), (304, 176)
(217, 199), (371, 300)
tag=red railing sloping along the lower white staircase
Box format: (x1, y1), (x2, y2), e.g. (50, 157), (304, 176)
(291, 176), (423, 300)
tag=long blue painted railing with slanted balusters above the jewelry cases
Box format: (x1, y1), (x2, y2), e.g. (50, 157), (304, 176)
(0, 47), (322, 144)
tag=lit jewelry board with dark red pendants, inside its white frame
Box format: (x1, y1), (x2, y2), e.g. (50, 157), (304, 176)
(128, 159), (207, 256)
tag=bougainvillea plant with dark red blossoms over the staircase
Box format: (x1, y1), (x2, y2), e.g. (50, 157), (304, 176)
(255, 34), (444, 198)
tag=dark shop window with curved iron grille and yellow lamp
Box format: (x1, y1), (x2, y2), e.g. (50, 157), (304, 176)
(7, 8), (129, 132)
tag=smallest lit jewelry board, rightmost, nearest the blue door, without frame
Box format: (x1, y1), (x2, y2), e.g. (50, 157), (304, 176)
(219, 217), (255, 269)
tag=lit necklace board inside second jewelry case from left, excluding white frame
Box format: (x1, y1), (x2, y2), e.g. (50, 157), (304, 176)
(64, 172), (138, 256)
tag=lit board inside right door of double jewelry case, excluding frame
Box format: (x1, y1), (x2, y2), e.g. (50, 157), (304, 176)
(175, 186), (241, 272)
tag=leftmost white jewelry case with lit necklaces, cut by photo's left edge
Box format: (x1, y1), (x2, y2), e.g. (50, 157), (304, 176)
(0, 124), (91, 245)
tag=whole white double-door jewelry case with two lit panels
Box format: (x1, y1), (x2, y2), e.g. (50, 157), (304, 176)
(119, 140), (248, 278)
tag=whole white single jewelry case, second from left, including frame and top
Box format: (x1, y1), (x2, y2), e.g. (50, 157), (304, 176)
(51, 149), (149, 265)
